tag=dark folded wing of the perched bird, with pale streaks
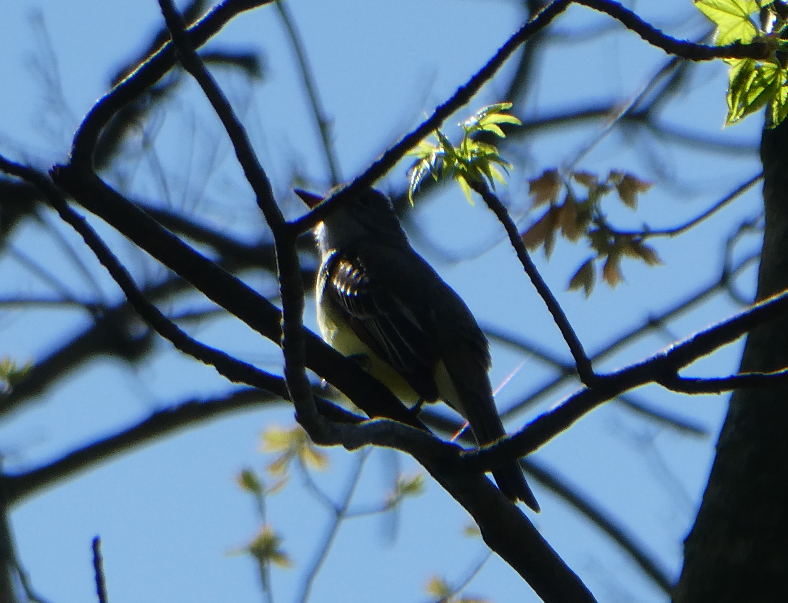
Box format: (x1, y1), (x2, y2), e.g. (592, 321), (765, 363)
(321, 250), (438, 401)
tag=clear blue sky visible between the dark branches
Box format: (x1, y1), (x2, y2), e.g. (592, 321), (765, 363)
(0, 0), (760, 603)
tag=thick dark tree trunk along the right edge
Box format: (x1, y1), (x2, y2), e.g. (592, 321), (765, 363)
(673, 122), (788, 603)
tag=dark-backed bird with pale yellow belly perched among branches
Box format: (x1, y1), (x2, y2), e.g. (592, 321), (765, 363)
(296, 189), (539, 511)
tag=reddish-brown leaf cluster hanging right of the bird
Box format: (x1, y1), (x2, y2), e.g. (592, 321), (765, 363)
(522, 169), (662, 296)
